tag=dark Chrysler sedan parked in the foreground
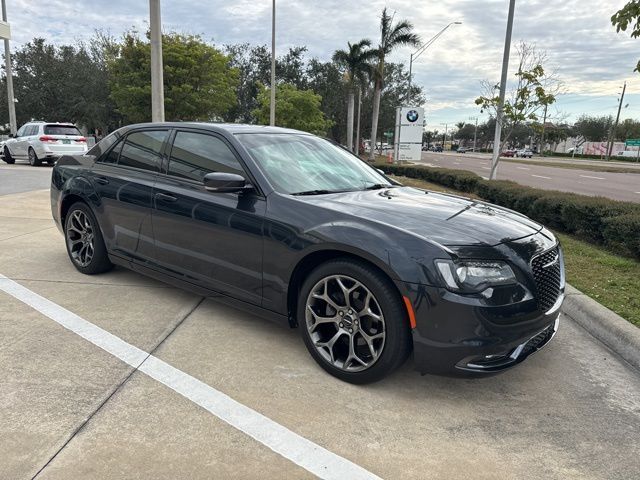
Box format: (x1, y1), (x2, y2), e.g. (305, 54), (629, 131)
(51, 123), (564, 383)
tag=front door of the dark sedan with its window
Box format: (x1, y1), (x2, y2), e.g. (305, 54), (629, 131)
(153, 129), (266, 305)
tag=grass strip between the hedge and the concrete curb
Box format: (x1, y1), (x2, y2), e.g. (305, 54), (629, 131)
(393, 173), (640, 327)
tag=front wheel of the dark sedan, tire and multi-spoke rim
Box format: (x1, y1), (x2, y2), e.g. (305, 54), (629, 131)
(296, 258), (411, 384)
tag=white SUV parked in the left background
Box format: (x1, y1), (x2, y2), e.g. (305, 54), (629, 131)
(2, 122), (87, 166)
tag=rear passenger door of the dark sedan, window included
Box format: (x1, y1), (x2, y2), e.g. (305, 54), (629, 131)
(91, 128), (169, 262)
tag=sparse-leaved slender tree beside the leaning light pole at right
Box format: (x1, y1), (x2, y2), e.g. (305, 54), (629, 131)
(475, 42), (560, 178)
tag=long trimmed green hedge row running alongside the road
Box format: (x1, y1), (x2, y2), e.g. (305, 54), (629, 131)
(383, 165), (640, 258)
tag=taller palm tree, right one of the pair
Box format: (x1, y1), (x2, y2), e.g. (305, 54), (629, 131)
(369, 7), (420, 162)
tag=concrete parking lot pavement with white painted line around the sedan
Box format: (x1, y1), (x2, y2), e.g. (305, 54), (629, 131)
(0, 164), (640, 479)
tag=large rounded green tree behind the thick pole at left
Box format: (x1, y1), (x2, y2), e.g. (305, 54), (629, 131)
(109, 32), (239, 123)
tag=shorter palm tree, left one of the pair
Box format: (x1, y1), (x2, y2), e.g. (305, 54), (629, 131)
(333, 39), (377, 151)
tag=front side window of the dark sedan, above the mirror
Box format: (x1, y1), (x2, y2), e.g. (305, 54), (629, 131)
(169, 132), (244, 181)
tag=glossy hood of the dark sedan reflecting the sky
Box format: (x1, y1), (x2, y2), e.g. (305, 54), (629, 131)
(299, 187), (542, 246)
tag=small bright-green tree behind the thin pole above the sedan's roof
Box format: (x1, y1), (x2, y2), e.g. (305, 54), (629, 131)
(254, 83), (331, 136)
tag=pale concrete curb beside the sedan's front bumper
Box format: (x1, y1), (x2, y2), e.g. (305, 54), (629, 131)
(562, 285), (640, 370)
